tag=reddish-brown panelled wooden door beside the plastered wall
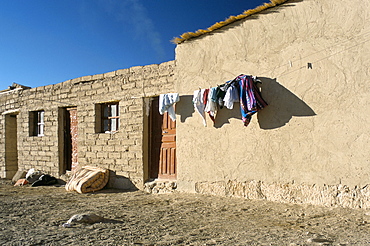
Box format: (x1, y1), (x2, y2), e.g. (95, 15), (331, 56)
(150, 97), (176, 179)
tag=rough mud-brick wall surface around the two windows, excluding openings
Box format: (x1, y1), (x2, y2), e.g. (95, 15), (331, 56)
(0, 61), (175, 188)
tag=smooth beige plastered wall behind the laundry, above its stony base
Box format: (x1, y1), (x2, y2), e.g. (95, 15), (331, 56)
(175, 0), (370, 207)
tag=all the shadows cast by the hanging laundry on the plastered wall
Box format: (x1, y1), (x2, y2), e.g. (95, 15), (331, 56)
(176, 77), (316, 130)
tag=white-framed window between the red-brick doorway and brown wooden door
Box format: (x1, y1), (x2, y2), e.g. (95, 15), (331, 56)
(96, 102), (119, 133)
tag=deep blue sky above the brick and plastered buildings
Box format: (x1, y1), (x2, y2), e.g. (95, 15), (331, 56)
(0, 0), (269, 90)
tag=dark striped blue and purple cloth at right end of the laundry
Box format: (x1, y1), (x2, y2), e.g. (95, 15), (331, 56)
(234, 74), (268, 126)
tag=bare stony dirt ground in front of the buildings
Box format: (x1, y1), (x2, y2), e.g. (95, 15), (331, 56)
(0, 180), (370, 245)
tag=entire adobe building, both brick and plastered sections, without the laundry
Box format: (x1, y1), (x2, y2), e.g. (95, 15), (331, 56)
(0, 0), (370, 208)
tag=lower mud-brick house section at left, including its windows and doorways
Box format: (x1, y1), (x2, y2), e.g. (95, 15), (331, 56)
(0, 61), (175, 189)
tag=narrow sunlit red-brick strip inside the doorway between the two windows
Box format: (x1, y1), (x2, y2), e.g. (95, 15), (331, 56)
(66, 108), (78, 170)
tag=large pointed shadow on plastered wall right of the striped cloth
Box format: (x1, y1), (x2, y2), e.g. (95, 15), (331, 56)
(257, 77), (316, 129)
